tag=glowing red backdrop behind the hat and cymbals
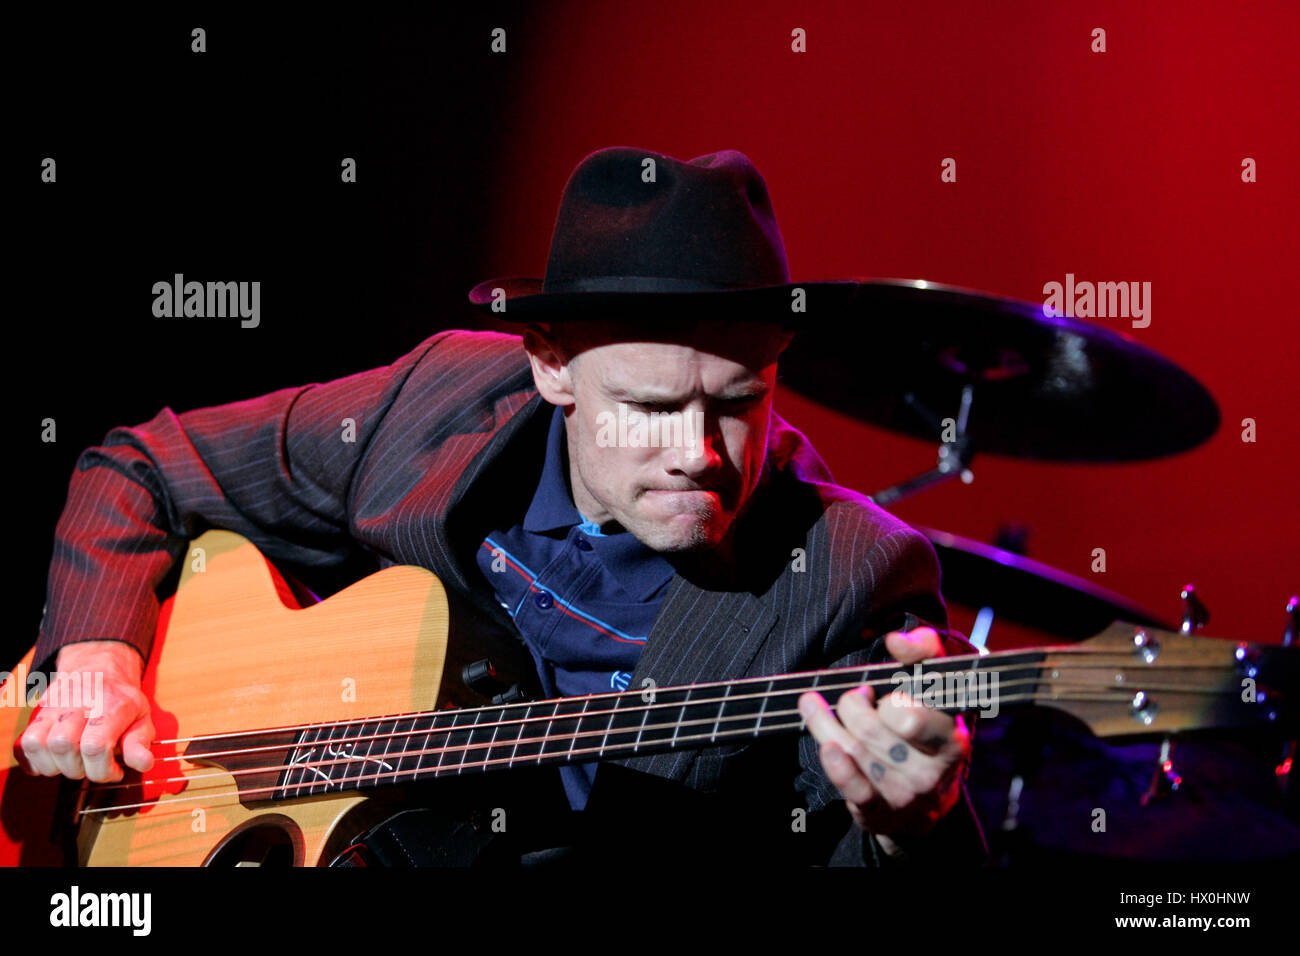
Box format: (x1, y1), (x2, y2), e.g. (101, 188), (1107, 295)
(482, 0), (1300, 640)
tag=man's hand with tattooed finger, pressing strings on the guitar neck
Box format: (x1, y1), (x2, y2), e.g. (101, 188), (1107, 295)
(800, 627), (971, 855)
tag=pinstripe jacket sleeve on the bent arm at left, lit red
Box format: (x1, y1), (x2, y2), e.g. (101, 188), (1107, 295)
(34, 333), (449, 670)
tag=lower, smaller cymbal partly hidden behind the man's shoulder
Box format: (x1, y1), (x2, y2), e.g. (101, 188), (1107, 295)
(913, 524), (1178, 640)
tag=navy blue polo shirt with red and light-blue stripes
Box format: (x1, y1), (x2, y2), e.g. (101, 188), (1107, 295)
(478, 407), (673, 810)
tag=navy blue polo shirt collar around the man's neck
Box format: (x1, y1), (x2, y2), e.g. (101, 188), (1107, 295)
(523, 406), (675, 601)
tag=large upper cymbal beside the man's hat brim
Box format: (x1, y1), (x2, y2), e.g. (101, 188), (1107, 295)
(780, 280), (1219, 462)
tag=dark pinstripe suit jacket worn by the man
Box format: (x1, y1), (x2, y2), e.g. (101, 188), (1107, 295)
(35, 332), (983, 864)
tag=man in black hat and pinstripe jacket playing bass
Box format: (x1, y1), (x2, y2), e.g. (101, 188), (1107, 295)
(20, 148), (984, 865)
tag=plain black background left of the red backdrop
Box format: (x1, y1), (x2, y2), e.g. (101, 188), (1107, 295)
(11, 4), (528, 661)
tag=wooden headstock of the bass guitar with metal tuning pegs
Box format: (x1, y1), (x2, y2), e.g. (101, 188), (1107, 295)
(1034, 620), (1300, 737)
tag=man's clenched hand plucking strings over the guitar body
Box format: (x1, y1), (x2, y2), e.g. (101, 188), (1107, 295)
(13, 641), (155, 783)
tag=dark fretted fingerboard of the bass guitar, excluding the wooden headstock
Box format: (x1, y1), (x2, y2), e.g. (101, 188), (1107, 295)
(186, 650), (1044, 800)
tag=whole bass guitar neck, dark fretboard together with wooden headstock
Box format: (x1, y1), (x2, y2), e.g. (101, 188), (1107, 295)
(185, 613), (1300, 800)
